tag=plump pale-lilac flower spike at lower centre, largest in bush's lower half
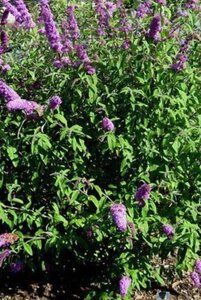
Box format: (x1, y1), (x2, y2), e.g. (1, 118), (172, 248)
(110, 204), (127, 231)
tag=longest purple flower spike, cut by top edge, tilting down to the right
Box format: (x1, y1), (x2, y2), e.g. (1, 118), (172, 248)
(40, 0), (63, 53)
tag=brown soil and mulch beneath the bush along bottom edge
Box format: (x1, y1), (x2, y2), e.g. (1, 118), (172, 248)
(0, 273), (201, 300)
